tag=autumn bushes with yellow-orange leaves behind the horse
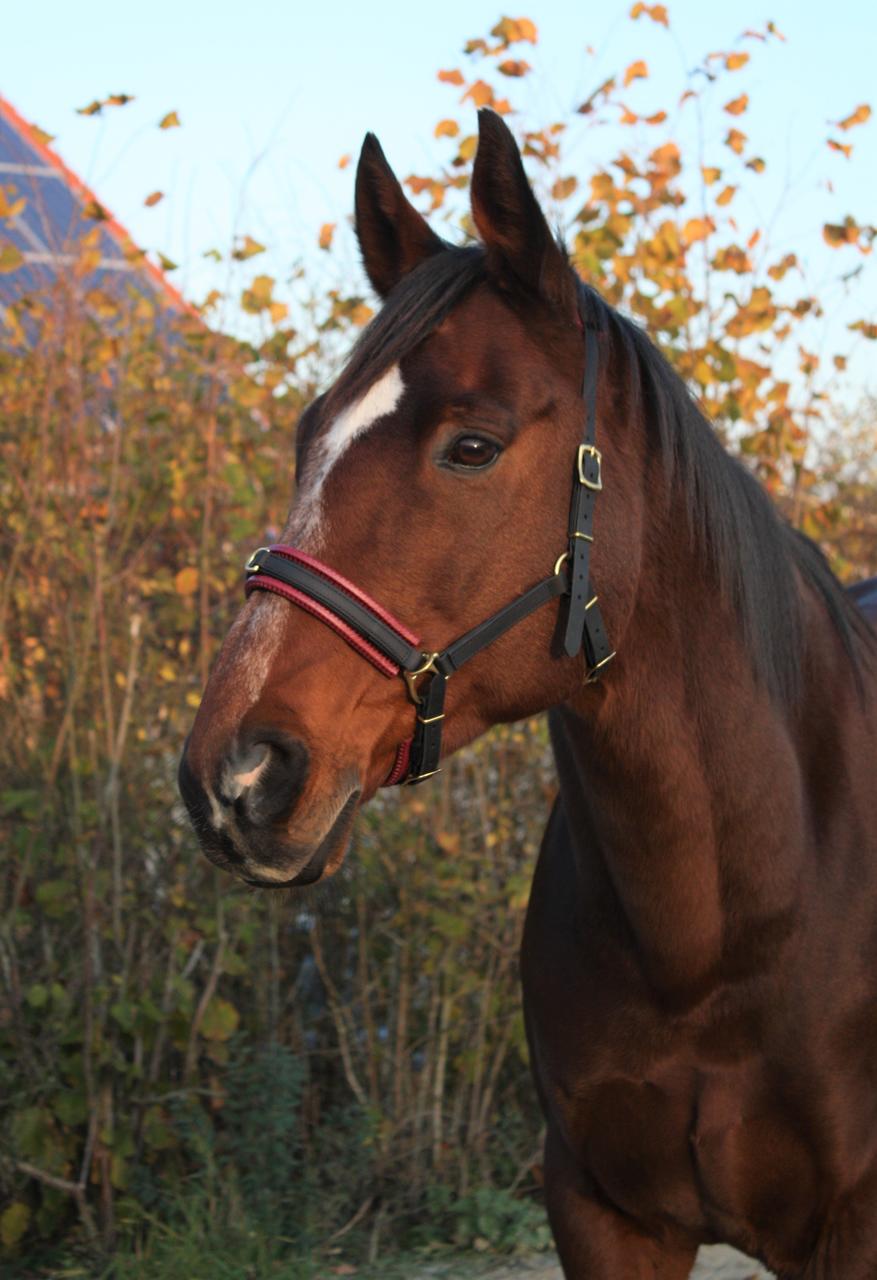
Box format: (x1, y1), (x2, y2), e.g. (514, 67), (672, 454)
(0, 12), (877, 1277)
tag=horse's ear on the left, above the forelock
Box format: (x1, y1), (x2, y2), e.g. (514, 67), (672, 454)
(356, 133), (447, 298)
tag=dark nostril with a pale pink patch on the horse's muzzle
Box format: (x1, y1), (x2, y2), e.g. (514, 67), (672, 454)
(220, 731), (309, 827)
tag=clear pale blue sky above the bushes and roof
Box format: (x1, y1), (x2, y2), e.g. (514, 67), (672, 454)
(0, 0), (877, 388)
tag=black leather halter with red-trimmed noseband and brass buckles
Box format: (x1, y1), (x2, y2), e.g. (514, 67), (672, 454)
(245, 319), (615, 786)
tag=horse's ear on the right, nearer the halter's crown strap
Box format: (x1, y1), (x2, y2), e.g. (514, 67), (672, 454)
(471, 109), (577, 320)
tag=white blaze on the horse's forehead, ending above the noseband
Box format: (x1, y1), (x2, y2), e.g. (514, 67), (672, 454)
(286, 365), (405, 552)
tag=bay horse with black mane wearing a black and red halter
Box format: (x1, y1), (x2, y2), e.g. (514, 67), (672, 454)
(181, 113), (877, 1280)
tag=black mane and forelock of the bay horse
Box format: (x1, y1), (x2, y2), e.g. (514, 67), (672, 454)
(329, 246), (874, 705)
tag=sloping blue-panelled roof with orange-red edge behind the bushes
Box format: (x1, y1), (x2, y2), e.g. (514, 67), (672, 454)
(0, 97), (191, 315)
